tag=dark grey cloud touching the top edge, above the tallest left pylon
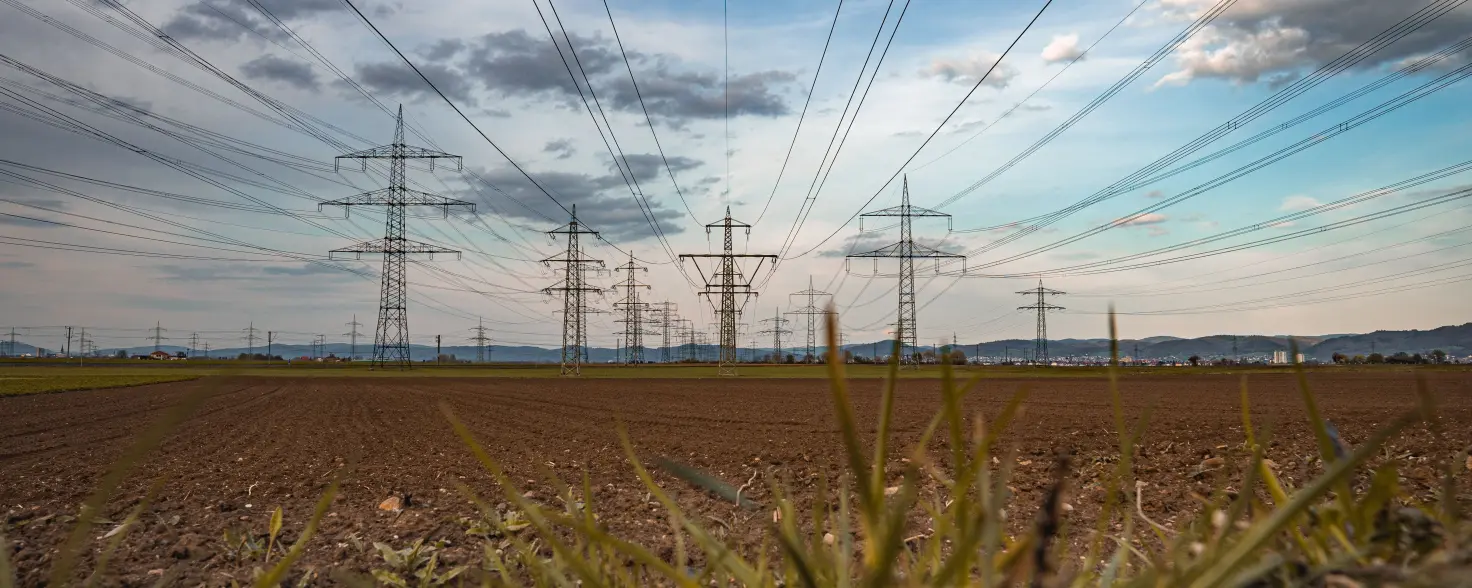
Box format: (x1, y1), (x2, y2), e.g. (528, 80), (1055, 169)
(162, 0), (343, 41)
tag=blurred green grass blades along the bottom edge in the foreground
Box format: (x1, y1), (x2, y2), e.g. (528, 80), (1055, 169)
(0, 312), (1472, 588)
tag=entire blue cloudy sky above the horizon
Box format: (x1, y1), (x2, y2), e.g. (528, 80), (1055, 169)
(0, 0), (1472, 348)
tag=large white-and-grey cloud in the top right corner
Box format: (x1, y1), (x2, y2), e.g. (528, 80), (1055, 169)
(1156, 0), (1472, 87)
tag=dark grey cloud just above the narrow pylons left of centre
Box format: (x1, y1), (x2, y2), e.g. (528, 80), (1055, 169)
(465, 159), (699, 242)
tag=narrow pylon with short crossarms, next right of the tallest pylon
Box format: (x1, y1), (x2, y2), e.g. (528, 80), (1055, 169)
(542, 205), (604, 376)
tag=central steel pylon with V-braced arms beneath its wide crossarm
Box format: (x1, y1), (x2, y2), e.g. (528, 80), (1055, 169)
(680, 206), (777, 376)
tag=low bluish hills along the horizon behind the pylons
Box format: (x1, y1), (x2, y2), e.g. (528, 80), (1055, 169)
(5, 323), (1472, 363)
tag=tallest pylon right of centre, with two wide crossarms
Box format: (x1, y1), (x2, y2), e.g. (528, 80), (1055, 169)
(845, 175), (966, 365)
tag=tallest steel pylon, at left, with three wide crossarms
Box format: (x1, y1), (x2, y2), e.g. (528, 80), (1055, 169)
(316, 105), (475, 368)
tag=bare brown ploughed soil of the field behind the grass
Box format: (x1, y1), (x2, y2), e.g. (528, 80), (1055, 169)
(0, 373), (1472, 585)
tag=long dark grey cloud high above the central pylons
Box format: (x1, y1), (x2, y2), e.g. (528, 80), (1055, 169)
(464, 29), (796, 124)
